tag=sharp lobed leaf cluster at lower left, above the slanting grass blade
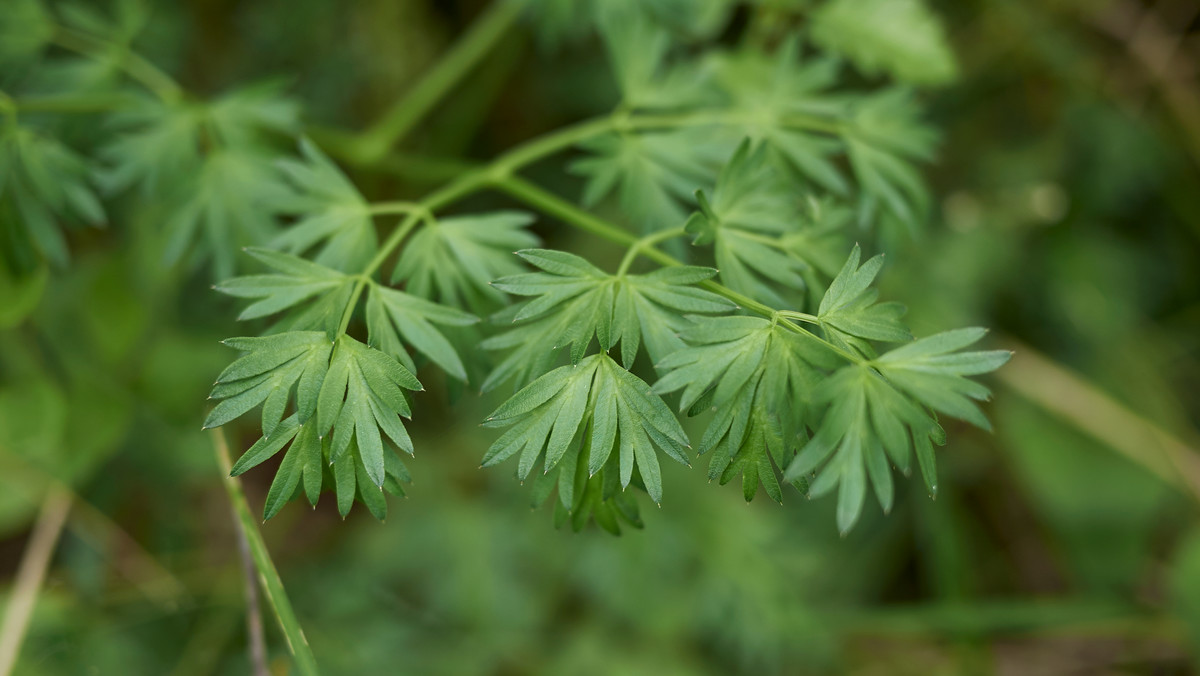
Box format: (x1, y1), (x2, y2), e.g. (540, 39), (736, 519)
(205, 331), (420, 515)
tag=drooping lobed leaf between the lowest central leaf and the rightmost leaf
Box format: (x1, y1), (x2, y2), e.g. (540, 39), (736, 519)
(654, 317), (840, 499)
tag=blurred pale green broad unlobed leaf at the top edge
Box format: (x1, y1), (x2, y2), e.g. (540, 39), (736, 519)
(811, 0), (958, 85)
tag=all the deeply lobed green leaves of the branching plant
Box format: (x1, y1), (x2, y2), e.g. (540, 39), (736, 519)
(0, 1), (1002, 532)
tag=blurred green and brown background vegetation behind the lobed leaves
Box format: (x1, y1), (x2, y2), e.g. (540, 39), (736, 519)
(0, 0), (1200, 675)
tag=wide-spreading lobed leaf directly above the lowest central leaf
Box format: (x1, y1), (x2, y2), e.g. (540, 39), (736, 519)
(481, 249), (733, 391)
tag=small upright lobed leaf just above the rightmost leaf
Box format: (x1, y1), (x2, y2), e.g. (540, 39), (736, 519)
(817, 244), (912, 353)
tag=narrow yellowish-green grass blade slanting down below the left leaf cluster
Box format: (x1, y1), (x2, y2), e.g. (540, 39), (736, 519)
(211, 429), (319, 676)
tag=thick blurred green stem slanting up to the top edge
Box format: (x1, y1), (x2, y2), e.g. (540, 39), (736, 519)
(353, 0), (524, 163)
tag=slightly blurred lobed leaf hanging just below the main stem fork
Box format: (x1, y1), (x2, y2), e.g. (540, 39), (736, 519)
(391, 211), (538, 316)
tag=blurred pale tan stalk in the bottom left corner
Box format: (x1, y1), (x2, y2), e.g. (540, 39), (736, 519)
(0, 484), (71, 676)
